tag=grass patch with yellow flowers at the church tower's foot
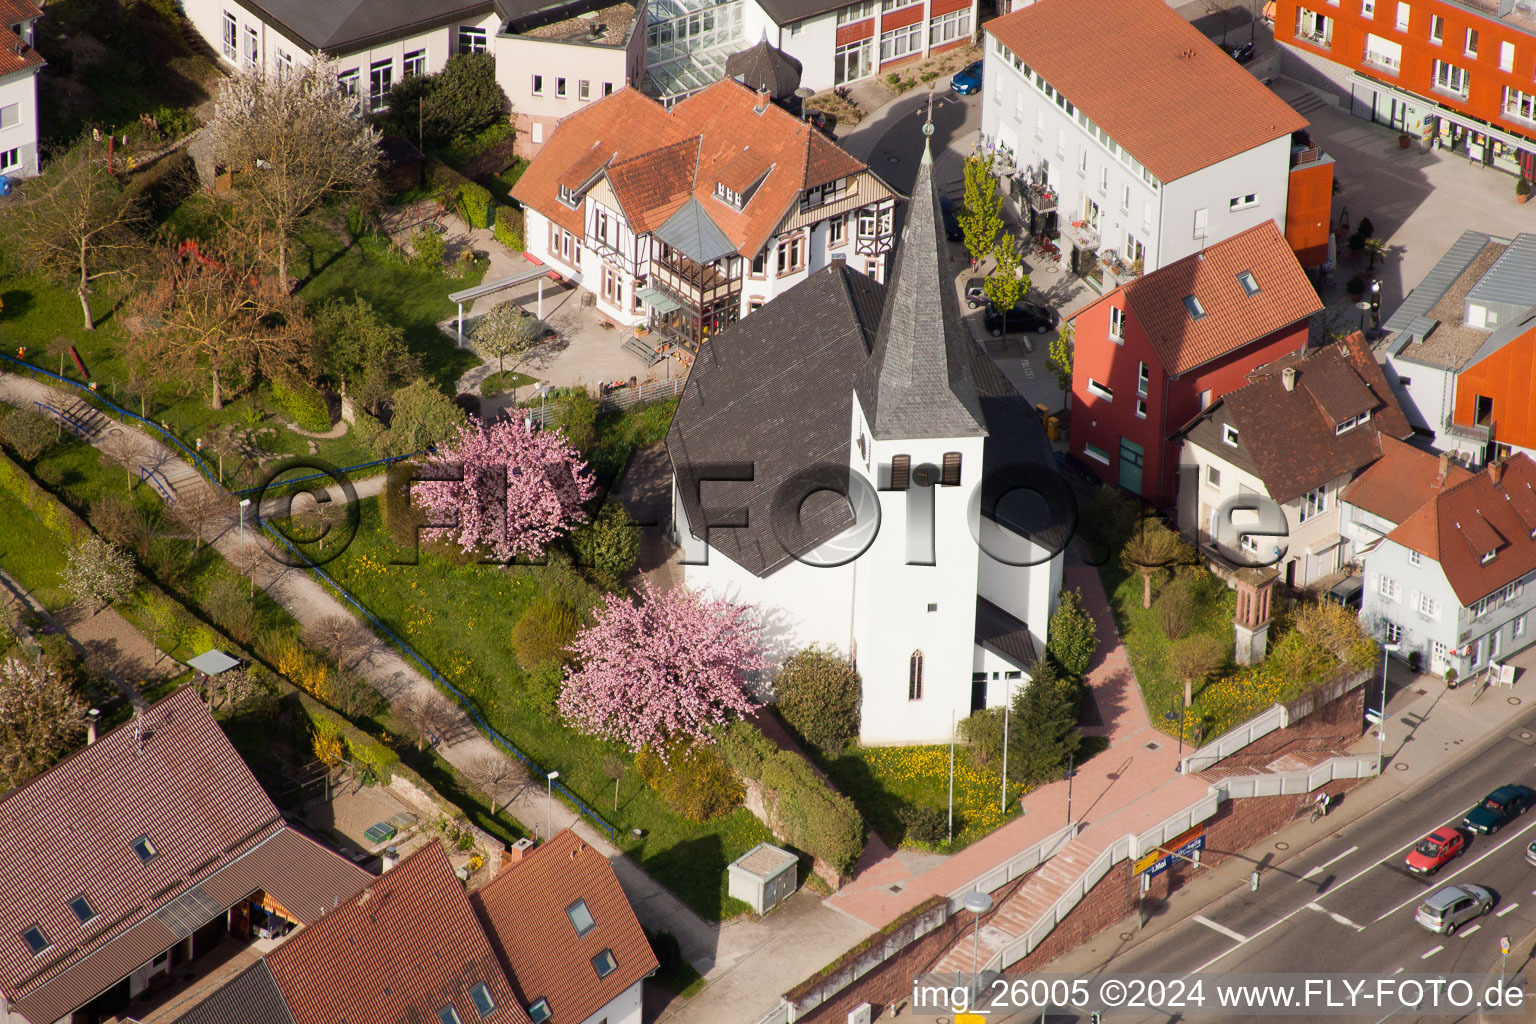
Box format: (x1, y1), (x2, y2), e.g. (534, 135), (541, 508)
(820, 743), (1029, 854)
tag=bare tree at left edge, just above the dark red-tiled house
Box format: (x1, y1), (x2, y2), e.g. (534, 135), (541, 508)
(0, 657), (86, 789)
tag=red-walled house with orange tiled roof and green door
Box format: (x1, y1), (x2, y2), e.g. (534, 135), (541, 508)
(1071, 221), (1322, 505)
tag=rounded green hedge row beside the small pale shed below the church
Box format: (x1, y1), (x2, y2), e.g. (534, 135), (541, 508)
(720, 722), (865, 875)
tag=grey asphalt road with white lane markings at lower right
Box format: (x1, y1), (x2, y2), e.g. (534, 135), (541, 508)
(989, 712), (1536, 1024)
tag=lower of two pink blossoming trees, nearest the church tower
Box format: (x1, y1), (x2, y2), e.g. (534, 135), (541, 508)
(559, 583), (768, 752)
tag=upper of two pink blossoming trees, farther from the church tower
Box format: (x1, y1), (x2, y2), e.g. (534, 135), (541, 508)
(412, 418), (598, 562)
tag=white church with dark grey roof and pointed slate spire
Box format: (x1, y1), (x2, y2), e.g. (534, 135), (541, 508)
(667, 134), (1072, 743)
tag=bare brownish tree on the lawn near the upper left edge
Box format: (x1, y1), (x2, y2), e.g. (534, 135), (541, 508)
(6, 138), (143, 330)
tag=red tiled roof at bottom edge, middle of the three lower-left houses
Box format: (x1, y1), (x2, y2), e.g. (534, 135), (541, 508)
(267, 841), (530, 1024)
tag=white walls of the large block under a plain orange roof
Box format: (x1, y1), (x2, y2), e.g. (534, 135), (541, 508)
(982, 37), (1290, 280)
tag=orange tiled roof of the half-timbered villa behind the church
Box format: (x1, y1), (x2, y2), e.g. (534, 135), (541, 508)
(513, 78), (894, 258)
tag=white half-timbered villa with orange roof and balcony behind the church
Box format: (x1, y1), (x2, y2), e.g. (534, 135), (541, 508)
(515, 80), (895, 359)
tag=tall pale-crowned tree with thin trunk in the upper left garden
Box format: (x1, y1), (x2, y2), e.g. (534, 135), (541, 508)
(209, 54), (379, 287)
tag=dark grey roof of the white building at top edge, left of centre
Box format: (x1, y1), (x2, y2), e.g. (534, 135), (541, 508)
(219, 0), (493, 55)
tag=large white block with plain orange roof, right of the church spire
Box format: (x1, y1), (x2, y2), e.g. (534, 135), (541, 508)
(982, 0), (1314, 290)
